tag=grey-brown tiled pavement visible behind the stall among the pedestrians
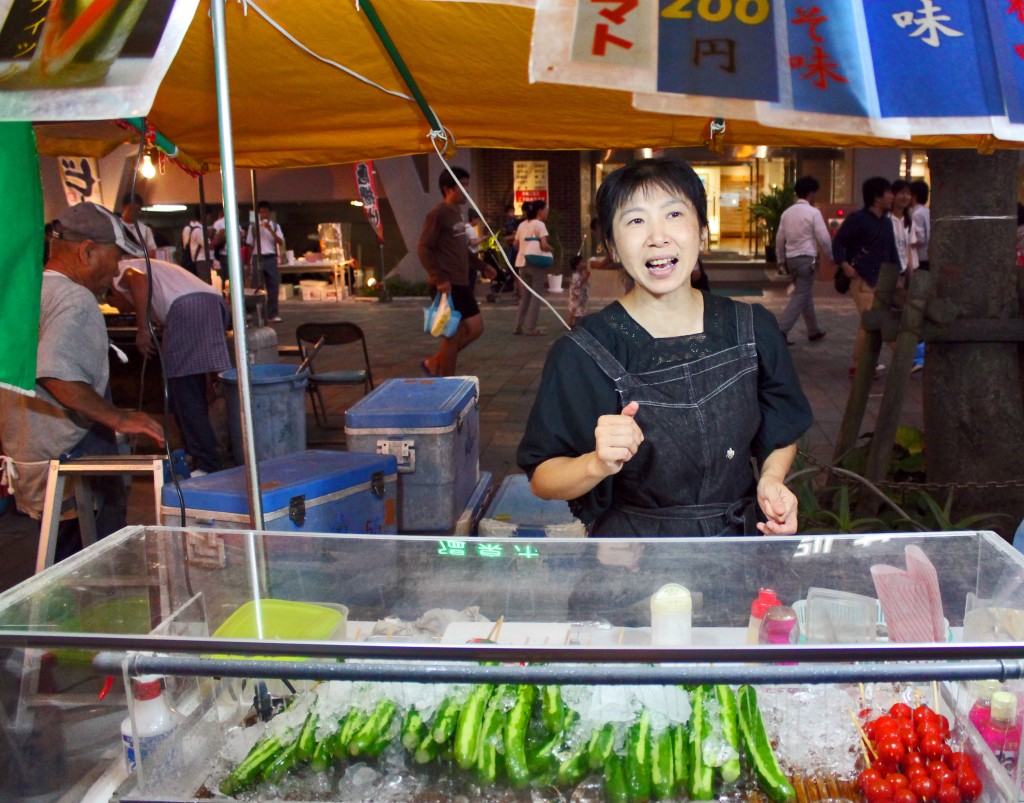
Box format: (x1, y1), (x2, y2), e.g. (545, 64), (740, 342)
(0, 276), (922, 589)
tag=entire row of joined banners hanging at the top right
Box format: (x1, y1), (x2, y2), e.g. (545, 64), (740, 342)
(530, 0), (1024, 139)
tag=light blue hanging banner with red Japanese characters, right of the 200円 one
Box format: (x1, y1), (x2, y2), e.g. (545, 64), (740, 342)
(785, 0), (878, 117)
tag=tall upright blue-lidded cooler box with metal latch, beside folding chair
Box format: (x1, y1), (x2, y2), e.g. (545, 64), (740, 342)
(345, 377), (480, 533)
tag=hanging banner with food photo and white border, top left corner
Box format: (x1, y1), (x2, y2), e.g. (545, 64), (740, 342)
(0, 0), (199, 122)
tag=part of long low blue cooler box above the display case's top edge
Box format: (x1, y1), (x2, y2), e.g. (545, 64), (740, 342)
(161, 451), (397, 533)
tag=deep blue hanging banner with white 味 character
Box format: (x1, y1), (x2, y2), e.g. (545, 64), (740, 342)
(862, 0), (1004, 117)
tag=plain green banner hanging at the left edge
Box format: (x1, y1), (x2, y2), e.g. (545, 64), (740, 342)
(0, 123), (43, 393)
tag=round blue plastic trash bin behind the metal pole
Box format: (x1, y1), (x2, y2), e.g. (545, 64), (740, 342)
(220, 365), (309, 465)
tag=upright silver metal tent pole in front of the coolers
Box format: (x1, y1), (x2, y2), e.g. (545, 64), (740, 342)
(210, 0), (264, 530)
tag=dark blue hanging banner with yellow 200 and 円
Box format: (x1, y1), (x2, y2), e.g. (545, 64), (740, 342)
(657, 0), (779, 102)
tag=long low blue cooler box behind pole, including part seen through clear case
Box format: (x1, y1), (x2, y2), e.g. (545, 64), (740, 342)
(161, 451), (398, 619)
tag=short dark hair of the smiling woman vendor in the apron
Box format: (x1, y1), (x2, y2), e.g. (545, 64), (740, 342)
(597, 157), (708, 253)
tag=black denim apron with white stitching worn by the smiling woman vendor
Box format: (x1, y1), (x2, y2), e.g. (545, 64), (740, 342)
(569, 304), (761, 537)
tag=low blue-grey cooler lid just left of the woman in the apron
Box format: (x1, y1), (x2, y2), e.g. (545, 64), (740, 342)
(477, 474), (587, 538)
